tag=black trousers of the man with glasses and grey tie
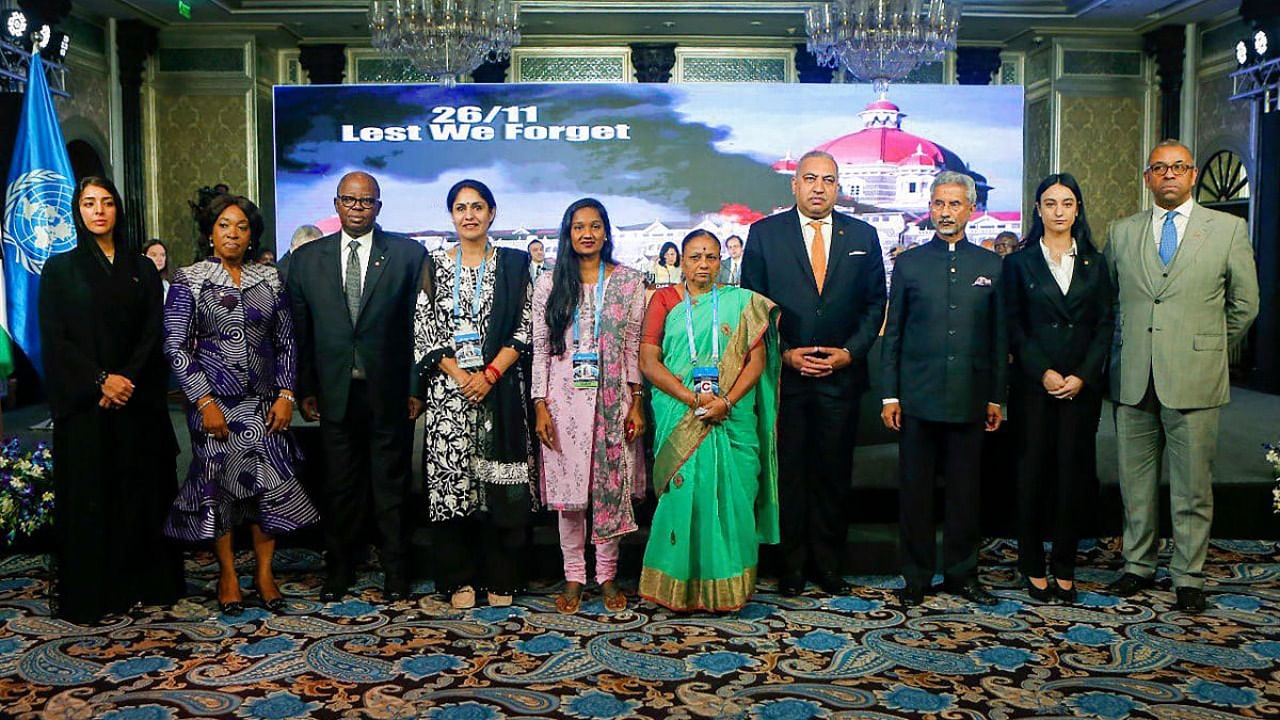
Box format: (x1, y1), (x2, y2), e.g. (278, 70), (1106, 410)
(320, 379), (413, 579)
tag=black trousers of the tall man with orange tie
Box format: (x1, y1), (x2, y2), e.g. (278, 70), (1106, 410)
(778, 389), (861, 577)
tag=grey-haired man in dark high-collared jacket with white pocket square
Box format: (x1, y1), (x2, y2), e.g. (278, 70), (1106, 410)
(881, 172), (1009, 606)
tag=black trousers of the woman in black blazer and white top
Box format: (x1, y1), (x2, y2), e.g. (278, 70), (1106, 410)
(1015, 386), (1102, 580)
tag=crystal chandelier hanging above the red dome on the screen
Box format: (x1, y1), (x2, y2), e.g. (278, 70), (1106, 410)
(805, 0), (963, 92)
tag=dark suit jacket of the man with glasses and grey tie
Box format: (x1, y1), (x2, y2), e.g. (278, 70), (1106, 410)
(288, 228), (426, 424)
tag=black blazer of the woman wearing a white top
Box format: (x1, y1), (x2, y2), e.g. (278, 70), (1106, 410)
(1005, 242), (1115, 389)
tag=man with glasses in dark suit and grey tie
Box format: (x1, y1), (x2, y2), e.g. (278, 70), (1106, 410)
(288, 172), (426, 601)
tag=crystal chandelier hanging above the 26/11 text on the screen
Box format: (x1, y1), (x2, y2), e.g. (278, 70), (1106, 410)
(369, 0), (520, 85)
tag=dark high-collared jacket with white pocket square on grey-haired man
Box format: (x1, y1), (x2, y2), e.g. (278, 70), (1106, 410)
(882, 237), (1009, 423)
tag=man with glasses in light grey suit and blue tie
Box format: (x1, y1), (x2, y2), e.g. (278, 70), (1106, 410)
(1105, 140), (1258, 612)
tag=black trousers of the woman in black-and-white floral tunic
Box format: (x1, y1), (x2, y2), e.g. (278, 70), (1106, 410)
(431, 484), (531, 594)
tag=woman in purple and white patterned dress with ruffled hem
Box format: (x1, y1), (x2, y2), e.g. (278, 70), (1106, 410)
(164, 195), (319, 615)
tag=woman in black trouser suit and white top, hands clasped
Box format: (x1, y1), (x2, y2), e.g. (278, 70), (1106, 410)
(1004, 173), (1115, 603)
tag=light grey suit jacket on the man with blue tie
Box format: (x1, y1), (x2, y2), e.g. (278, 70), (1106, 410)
(1105, 199), (1258, 410)
